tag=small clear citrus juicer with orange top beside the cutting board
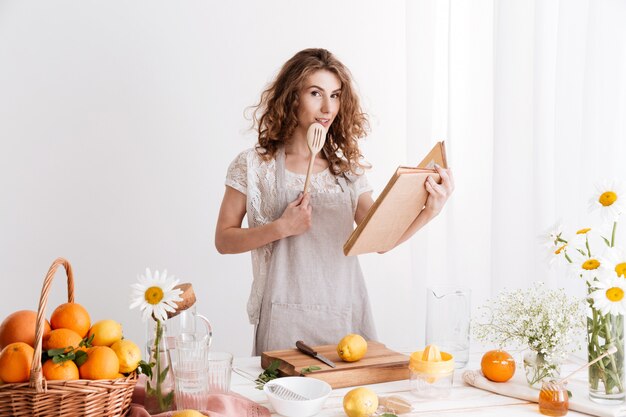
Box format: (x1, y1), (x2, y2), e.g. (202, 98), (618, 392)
(409, 345), (454, 399)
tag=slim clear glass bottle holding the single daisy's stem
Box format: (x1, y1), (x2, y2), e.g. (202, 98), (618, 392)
(144, 320), (176, 414)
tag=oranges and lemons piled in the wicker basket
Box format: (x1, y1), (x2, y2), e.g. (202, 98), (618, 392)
(0, 303), (141, 383)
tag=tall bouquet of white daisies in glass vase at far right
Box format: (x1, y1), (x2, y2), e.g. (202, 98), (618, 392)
(547, 183), (626, 404)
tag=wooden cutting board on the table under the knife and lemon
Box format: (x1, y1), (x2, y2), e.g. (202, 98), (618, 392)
(261, 341), (409, 388)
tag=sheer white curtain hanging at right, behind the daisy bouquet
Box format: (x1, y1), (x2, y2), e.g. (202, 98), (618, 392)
(407, 0), (626, 322)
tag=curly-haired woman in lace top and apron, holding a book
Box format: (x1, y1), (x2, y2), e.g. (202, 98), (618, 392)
(215, 49), (454, 355)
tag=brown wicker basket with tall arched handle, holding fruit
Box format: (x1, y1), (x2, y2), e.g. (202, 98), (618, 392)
(0, 258), (137, 417)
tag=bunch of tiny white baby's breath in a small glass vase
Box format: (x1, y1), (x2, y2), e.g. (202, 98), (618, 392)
(473, 282), (585, 387)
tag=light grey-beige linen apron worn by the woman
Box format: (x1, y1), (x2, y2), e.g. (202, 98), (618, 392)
(255, 149), (376, 355)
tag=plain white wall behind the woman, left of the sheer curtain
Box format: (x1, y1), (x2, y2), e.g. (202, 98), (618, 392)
(0, 0), (439, 355)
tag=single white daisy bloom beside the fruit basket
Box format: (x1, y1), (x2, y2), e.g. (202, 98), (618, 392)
(130, 268), (183, 321)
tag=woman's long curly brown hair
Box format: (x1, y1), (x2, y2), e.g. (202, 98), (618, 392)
(252, 48), (369, 175)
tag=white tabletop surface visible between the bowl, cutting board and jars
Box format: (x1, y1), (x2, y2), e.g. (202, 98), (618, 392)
(231, 353), (587, 417)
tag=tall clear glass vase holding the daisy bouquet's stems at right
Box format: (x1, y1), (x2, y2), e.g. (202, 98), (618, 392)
(587, 307), (624, 405)
